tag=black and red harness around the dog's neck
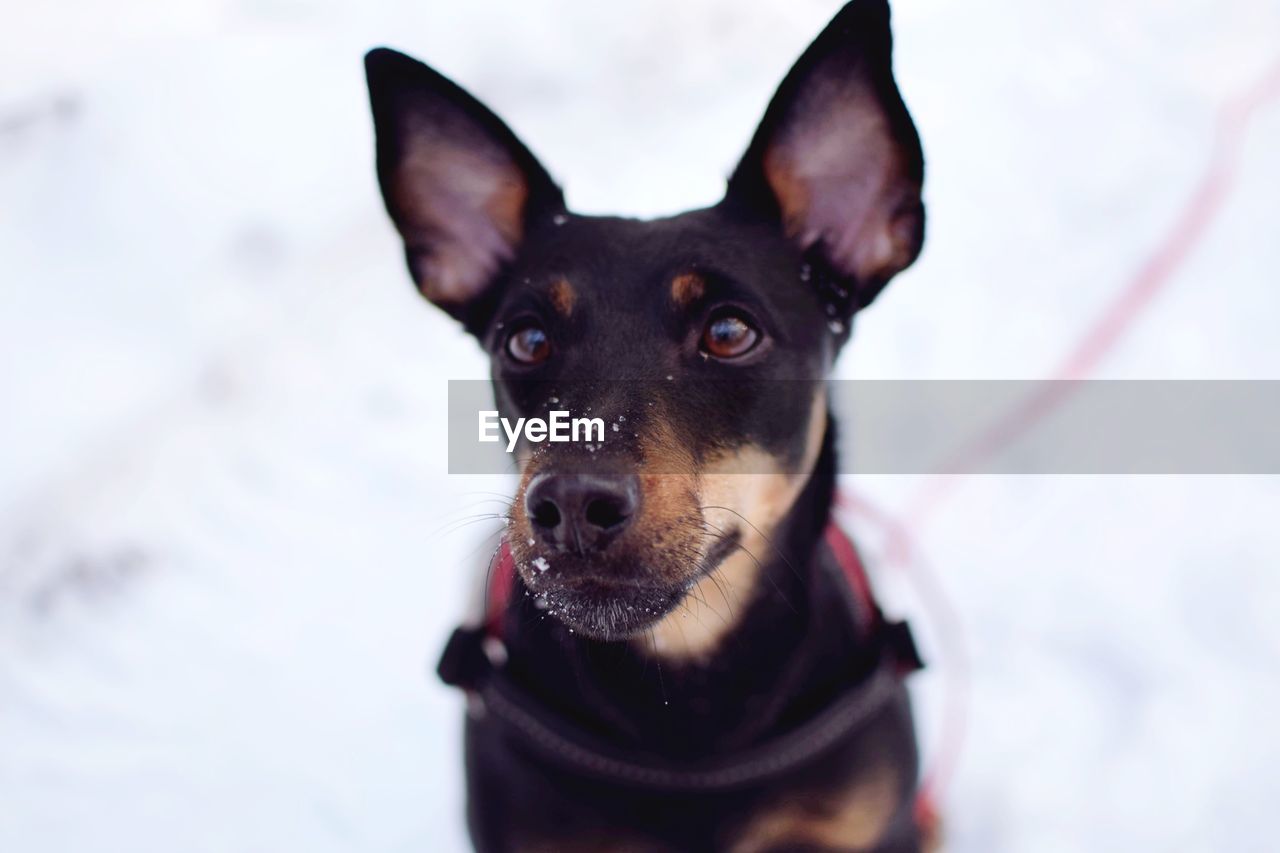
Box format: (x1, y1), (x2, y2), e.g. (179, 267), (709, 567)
(438, 524), (923, 793)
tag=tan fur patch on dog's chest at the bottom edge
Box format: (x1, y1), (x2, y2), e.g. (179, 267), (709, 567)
(730, 767), (900, 853)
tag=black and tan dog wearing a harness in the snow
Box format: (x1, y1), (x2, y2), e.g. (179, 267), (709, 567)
(366, 0), (925, 853)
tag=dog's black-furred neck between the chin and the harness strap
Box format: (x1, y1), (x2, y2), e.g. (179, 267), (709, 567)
(504, 429), (874, 757)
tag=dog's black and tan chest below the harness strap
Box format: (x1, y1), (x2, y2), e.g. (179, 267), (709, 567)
(467, 713), (919, 853)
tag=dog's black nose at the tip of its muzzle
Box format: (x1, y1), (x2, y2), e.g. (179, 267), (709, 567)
(525, 473), (640, 553)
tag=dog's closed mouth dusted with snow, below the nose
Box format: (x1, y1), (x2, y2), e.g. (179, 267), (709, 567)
(521, 530), (739, 640)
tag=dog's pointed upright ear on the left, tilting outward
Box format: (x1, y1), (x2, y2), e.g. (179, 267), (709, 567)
(365, 47), (564, 332)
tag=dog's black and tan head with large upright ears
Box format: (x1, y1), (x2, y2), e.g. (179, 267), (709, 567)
(366, 0), (924, 639)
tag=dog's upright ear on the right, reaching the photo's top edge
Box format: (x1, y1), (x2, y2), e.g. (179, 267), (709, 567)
(726, 0), (924, 314)
